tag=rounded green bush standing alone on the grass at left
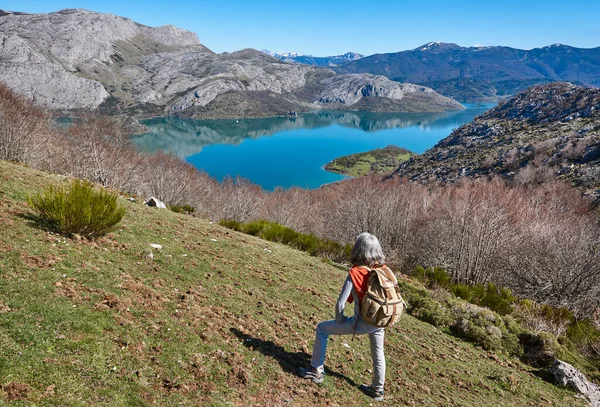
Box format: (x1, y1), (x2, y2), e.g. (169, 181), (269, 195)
(27, 180), (125, 239)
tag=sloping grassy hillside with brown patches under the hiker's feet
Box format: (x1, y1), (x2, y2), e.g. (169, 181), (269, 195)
(0, 161), (585, 406)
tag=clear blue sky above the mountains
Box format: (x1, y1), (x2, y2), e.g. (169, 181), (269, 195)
(0, 0), (600, 56)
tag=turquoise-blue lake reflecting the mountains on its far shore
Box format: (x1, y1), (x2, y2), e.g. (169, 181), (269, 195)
(133, 104), (494, 190)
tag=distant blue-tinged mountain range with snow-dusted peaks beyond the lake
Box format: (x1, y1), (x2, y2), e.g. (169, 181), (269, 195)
(333, 42), (600, 102)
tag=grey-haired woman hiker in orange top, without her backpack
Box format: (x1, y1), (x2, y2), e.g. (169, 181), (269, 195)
(298, 233), (385, 401)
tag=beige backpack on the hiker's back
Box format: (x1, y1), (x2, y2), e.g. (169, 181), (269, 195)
(360, 266), (406, 328)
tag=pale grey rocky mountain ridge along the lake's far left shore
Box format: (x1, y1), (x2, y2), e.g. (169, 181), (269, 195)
(0, 9), (462, 118)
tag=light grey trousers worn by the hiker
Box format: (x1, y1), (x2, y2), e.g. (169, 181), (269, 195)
(310, 316), (385, 390)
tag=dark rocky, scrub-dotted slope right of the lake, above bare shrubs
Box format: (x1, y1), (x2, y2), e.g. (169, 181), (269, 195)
(396, 82), (600, 199)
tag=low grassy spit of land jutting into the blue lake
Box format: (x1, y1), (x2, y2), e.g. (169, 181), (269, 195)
(325, 146), (416, 177)
